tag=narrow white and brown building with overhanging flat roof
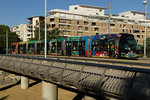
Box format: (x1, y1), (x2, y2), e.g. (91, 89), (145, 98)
(27, 16), (45, 38)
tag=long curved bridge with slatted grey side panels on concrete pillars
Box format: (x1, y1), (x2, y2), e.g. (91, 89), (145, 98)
(0, 55), (150, 100)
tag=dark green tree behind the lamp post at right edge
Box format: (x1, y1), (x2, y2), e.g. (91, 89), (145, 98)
(141, 38), (150, 57)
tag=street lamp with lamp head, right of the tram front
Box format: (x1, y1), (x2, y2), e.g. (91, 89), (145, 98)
(143, 0), (147, 58)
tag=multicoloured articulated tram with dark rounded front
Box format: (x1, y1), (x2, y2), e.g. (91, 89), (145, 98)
(10, 33), (141, 58)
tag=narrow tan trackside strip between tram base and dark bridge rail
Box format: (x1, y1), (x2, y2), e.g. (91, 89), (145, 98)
(23, 55), (150, 67)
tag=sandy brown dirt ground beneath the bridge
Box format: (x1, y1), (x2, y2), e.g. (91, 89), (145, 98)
(0, 80), (76, 100)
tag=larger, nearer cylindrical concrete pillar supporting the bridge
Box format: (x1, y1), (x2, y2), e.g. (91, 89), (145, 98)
(42, 81), (58, 100)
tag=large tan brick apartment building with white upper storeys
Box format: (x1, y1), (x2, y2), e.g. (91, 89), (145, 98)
(47, 5), (150, 44)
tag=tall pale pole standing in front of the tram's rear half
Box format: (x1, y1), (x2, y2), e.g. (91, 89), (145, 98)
(45, 0), (47, 58)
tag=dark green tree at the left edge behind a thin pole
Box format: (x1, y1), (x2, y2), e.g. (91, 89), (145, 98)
(0, 25), (20, 53)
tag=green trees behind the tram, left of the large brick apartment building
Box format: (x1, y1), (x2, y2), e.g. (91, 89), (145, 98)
(33, 21), (61, 40)
